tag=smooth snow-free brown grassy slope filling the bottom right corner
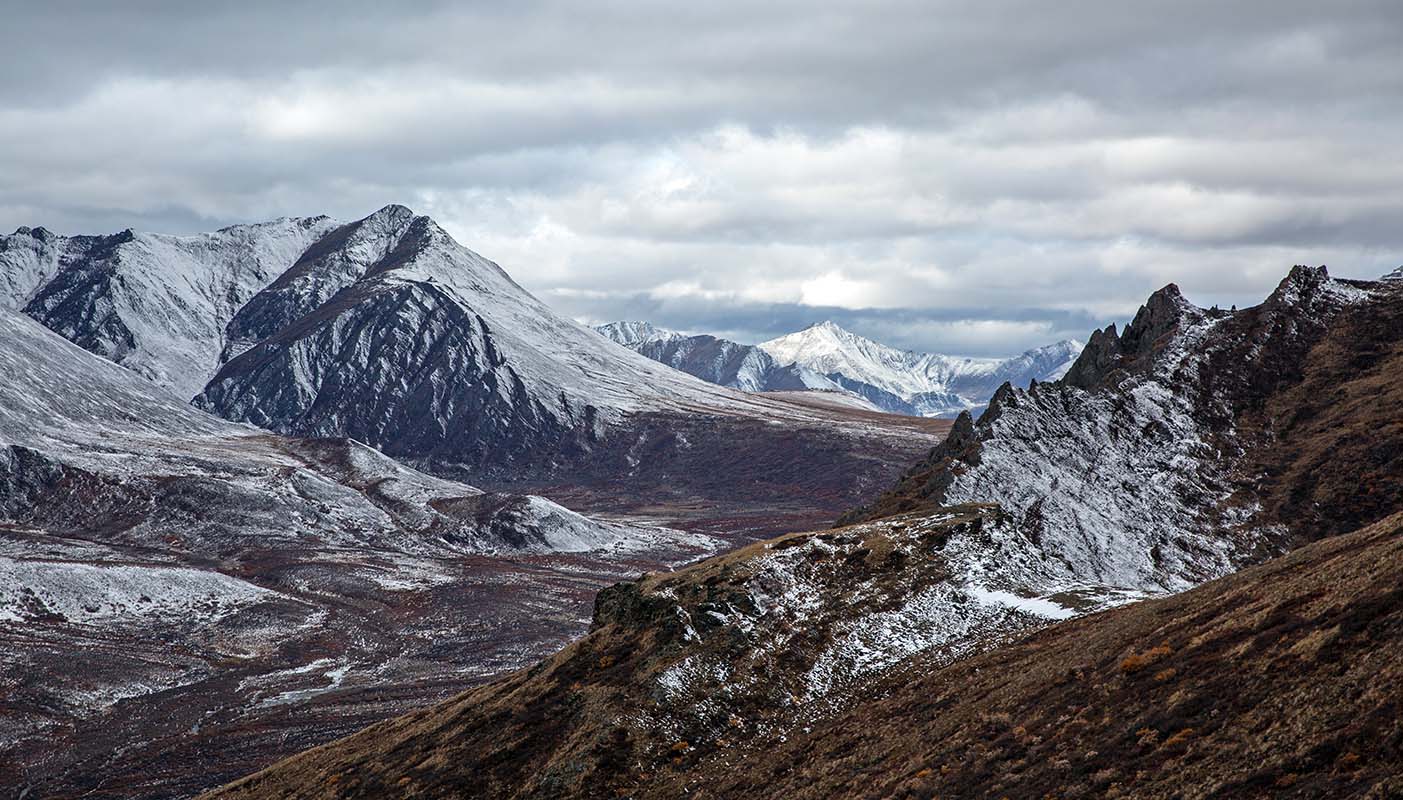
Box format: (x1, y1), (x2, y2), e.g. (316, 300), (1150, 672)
(707, 515), (1403, 800)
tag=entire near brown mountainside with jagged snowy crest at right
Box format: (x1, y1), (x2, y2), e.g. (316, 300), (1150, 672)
(200, 267), (1403, 797)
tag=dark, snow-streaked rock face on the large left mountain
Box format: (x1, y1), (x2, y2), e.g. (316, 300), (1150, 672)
(196, 284), (595, 470)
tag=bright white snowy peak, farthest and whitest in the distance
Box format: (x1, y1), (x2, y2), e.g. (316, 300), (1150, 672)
(759, 321), (1082, 417)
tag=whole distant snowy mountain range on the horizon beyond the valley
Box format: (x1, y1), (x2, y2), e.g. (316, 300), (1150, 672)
(595, 321), (1082, 417)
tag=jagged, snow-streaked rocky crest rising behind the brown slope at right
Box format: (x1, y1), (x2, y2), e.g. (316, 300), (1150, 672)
(845, 267), (1403, 589)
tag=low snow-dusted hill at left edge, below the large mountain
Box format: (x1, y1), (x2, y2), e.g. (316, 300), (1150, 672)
(0, 312), (690, 554)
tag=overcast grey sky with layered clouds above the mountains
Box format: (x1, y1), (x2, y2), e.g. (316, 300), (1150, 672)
(0, 0), (1403, 355)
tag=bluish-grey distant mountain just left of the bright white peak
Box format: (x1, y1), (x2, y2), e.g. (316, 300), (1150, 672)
(595, 321), (842, 392)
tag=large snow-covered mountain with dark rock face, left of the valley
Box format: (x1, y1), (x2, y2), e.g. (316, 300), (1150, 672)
(0, 205), (943, 525)
